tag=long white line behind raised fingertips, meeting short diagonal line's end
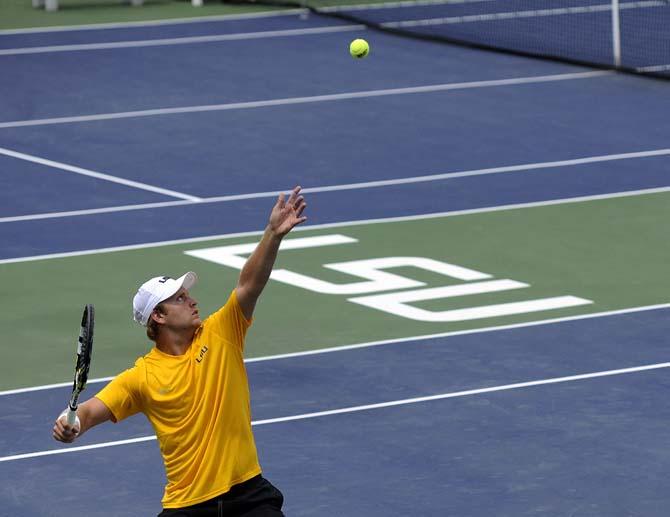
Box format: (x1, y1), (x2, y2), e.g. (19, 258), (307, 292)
(0, 149), (670, 224)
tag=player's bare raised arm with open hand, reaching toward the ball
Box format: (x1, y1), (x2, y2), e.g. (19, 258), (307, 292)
(236, 186), (307, 319)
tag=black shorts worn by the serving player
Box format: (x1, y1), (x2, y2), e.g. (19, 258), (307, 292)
(158, 474), (284, 517)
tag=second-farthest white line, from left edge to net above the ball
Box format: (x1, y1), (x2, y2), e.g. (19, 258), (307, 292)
(0, 25), (366, 56)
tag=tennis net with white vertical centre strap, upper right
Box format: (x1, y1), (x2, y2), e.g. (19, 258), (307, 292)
(229, 0), (670, 79)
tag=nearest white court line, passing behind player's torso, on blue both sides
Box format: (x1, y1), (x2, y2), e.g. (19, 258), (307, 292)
(0, 363), (670, 463)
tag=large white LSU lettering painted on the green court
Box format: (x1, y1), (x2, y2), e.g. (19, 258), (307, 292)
(184, 234), (593, 323)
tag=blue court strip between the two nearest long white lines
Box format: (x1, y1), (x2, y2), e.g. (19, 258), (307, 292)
(0, 304), (670, 462)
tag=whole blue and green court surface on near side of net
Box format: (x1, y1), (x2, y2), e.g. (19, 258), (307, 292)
(0, 4), (670, 517)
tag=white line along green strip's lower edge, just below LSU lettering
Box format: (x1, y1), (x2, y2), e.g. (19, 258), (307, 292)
(0, 303), (670, 397)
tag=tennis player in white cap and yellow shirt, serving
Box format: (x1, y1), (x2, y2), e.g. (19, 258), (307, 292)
(53, 187), (306, 517)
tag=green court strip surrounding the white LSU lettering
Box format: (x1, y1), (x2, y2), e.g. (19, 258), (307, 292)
(0, 193), (670, 389)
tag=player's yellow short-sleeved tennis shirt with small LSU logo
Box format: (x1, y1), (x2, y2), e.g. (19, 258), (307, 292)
(96, 291), (261, 508)
